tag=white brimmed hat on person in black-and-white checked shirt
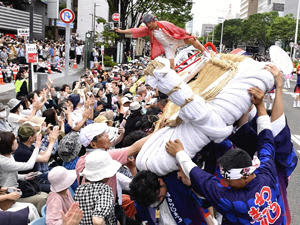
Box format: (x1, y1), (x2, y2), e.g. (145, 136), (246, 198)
(82, 150), (121, 181)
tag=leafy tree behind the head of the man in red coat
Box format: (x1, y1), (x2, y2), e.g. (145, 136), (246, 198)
(107, 0), (193, 28)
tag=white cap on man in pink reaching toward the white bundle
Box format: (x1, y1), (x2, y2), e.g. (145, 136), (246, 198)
(79, 123), (107, 147)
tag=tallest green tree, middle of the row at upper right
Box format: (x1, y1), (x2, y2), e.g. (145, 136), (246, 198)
(242, 12), (278, 48)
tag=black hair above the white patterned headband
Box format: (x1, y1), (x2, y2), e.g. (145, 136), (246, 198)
(218, 148), (252, 170)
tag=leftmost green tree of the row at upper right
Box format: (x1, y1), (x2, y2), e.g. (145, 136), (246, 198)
(214, 19), (243, 48)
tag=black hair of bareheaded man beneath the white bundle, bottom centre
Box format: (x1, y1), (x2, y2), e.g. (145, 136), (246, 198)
(129, 171), (160, 207)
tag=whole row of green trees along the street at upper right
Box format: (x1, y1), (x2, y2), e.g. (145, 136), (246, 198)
(214, 12), (300, 49)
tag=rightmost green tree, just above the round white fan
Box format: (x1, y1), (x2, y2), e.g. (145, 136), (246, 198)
(267, 15), (296, 48)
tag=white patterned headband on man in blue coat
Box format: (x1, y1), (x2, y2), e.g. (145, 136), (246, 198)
(220, 156), (260, 180)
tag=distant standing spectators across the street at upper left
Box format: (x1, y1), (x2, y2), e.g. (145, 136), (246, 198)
(0, 35), (84, 83)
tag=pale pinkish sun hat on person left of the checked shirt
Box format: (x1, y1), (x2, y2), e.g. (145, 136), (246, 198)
(48, 166), (76, 192)
